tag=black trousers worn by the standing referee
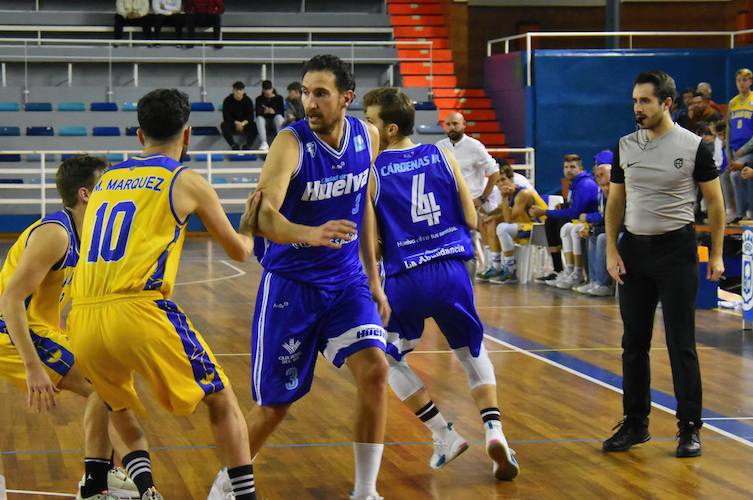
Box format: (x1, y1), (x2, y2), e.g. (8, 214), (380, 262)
(618, 224), (702, 425)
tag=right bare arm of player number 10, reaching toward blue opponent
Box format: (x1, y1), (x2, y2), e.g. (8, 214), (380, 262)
(173, 170), (254, 262)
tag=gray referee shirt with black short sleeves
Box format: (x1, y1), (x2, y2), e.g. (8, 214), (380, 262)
(612, 124), (719, 235)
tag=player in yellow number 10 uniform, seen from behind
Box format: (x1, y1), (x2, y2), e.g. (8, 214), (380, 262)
(69, 89), (256, 500)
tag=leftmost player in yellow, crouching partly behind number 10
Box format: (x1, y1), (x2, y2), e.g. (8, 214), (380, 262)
(0, 156), (135, 499)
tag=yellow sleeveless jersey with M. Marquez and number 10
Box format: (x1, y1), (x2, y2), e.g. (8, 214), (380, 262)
(72, 155), (186, 300)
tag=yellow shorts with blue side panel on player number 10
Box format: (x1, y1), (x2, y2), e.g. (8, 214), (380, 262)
(68, 292), (230, 415)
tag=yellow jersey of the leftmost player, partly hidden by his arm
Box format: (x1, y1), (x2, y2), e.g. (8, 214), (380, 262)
(0, 210), (79, 331)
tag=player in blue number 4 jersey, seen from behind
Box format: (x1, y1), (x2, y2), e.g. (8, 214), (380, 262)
(364, 88), (519, 480)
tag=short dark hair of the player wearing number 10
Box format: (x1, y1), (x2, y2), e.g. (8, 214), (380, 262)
(138, 89), (191, 142)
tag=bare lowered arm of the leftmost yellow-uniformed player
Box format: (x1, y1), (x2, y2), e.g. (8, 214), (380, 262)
(0, 224), (68, 411)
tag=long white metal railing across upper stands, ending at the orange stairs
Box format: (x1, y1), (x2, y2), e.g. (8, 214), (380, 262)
(0, 38), (434, 98)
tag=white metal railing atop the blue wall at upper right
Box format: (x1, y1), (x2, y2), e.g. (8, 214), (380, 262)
(486, 29), (753, 87)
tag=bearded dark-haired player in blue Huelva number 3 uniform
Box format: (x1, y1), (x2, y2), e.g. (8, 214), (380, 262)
(247, 55), (387, 500)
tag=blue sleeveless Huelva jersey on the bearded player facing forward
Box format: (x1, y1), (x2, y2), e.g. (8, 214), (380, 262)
(257, 116), (371, 290)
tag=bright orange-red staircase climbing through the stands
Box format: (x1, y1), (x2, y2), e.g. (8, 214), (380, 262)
(387, 0), (505, 150)
